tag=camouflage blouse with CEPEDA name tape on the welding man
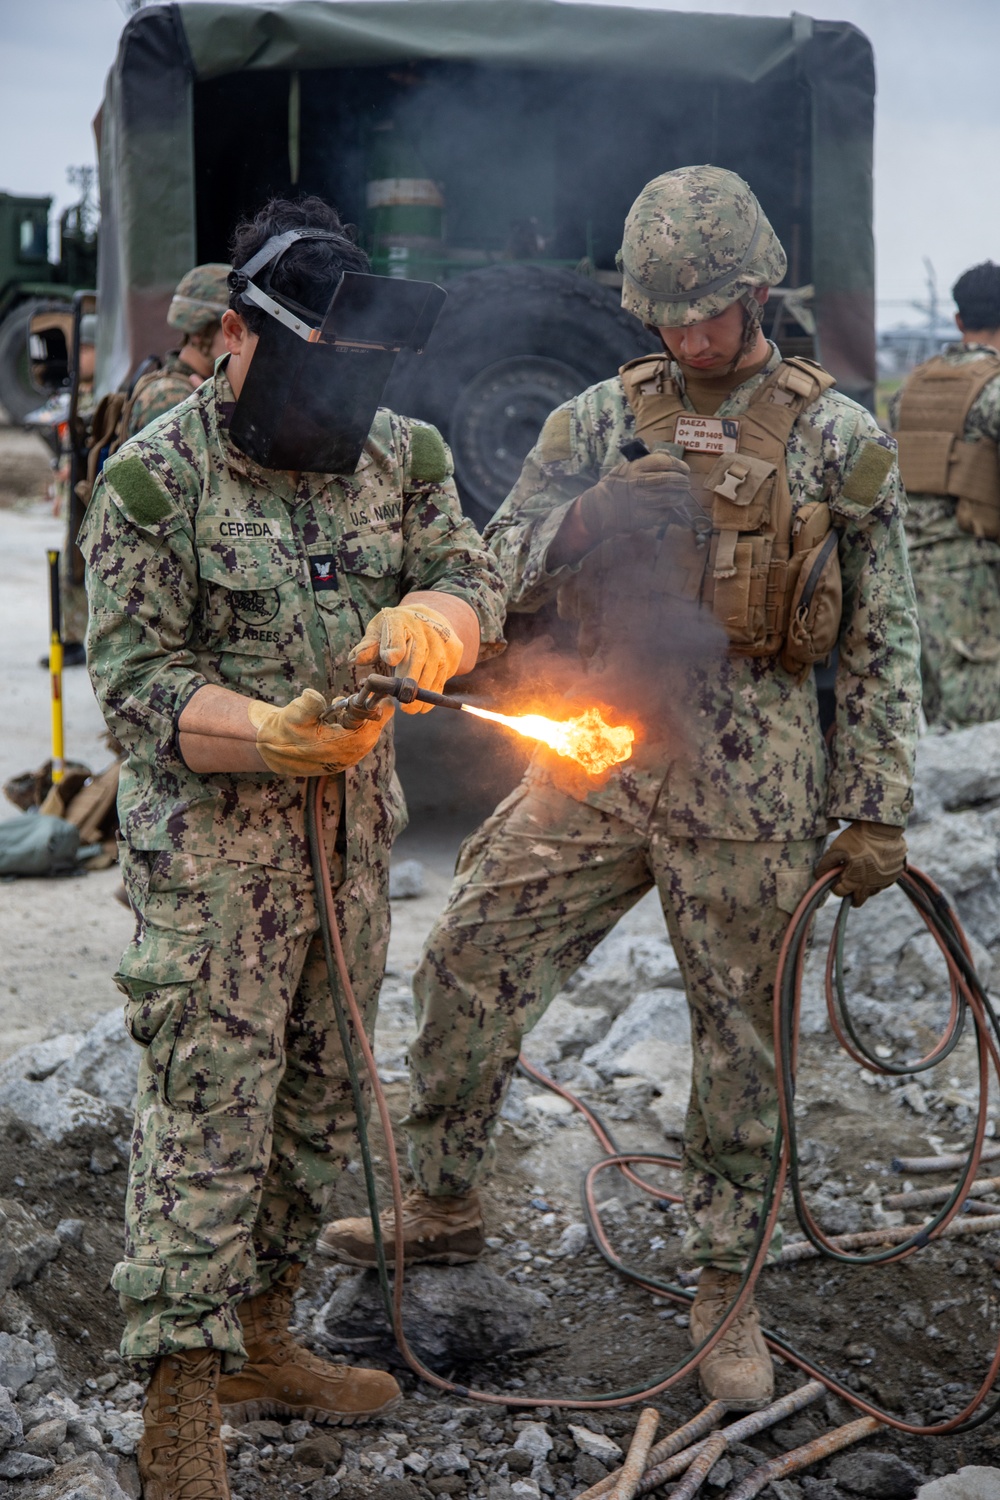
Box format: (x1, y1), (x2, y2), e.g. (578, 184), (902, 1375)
(79, 365), (504, 870)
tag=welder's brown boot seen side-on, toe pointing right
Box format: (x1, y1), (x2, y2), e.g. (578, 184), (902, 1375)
(219, 1266), (402, 1427)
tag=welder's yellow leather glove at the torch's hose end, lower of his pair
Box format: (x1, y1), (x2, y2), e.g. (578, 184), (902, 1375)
(247, 687), (393, 776)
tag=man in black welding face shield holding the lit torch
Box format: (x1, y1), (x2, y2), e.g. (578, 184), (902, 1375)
(81, 198), (504, 1500)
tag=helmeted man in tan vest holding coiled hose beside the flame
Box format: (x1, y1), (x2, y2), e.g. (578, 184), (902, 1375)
(319, 167), (919, 1407)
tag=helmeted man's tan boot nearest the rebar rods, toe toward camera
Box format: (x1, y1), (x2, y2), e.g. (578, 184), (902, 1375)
(691, 1266), (774, 1412)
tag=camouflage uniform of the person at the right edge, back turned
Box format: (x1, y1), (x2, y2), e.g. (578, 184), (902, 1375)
(889, 344), (1000, 728)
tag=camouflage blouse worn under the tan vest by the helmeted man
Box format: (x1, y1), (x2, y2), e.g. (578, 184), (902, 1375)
(486, 347), (921, 840)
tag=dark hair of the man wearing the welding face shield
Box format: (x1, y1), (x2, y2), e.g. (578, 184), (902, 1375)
(229, 197), (370, 333)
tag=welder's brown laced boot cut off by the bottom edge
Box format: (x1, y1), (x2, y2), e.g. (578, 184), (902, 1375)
(136, 1349), (229, 1500)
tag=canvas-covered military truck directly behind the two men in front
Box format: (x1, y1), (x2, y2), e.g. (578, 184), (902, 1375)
(97, 0), (876, 524)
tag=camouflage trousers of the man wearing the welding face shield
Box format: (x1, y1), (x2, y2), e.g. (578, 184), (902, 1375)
(111, 854), (388, 1368)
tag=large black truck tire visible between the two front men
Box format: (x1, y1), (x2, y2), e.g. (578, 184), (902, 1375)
(384, 266), (660, 527)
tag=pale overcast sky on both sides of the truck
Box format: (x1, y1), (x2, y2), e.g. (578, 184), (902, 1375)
(0, 0), (1000, 326)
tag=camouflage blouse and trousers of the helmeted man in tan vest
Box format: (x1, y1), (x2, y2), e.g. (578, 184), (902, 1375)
(406, 348), (919, 1269)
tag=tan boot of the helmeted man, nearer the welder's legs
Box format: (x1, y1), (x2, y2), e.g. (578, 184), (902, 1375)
(316, 1190), (486, 1266)
